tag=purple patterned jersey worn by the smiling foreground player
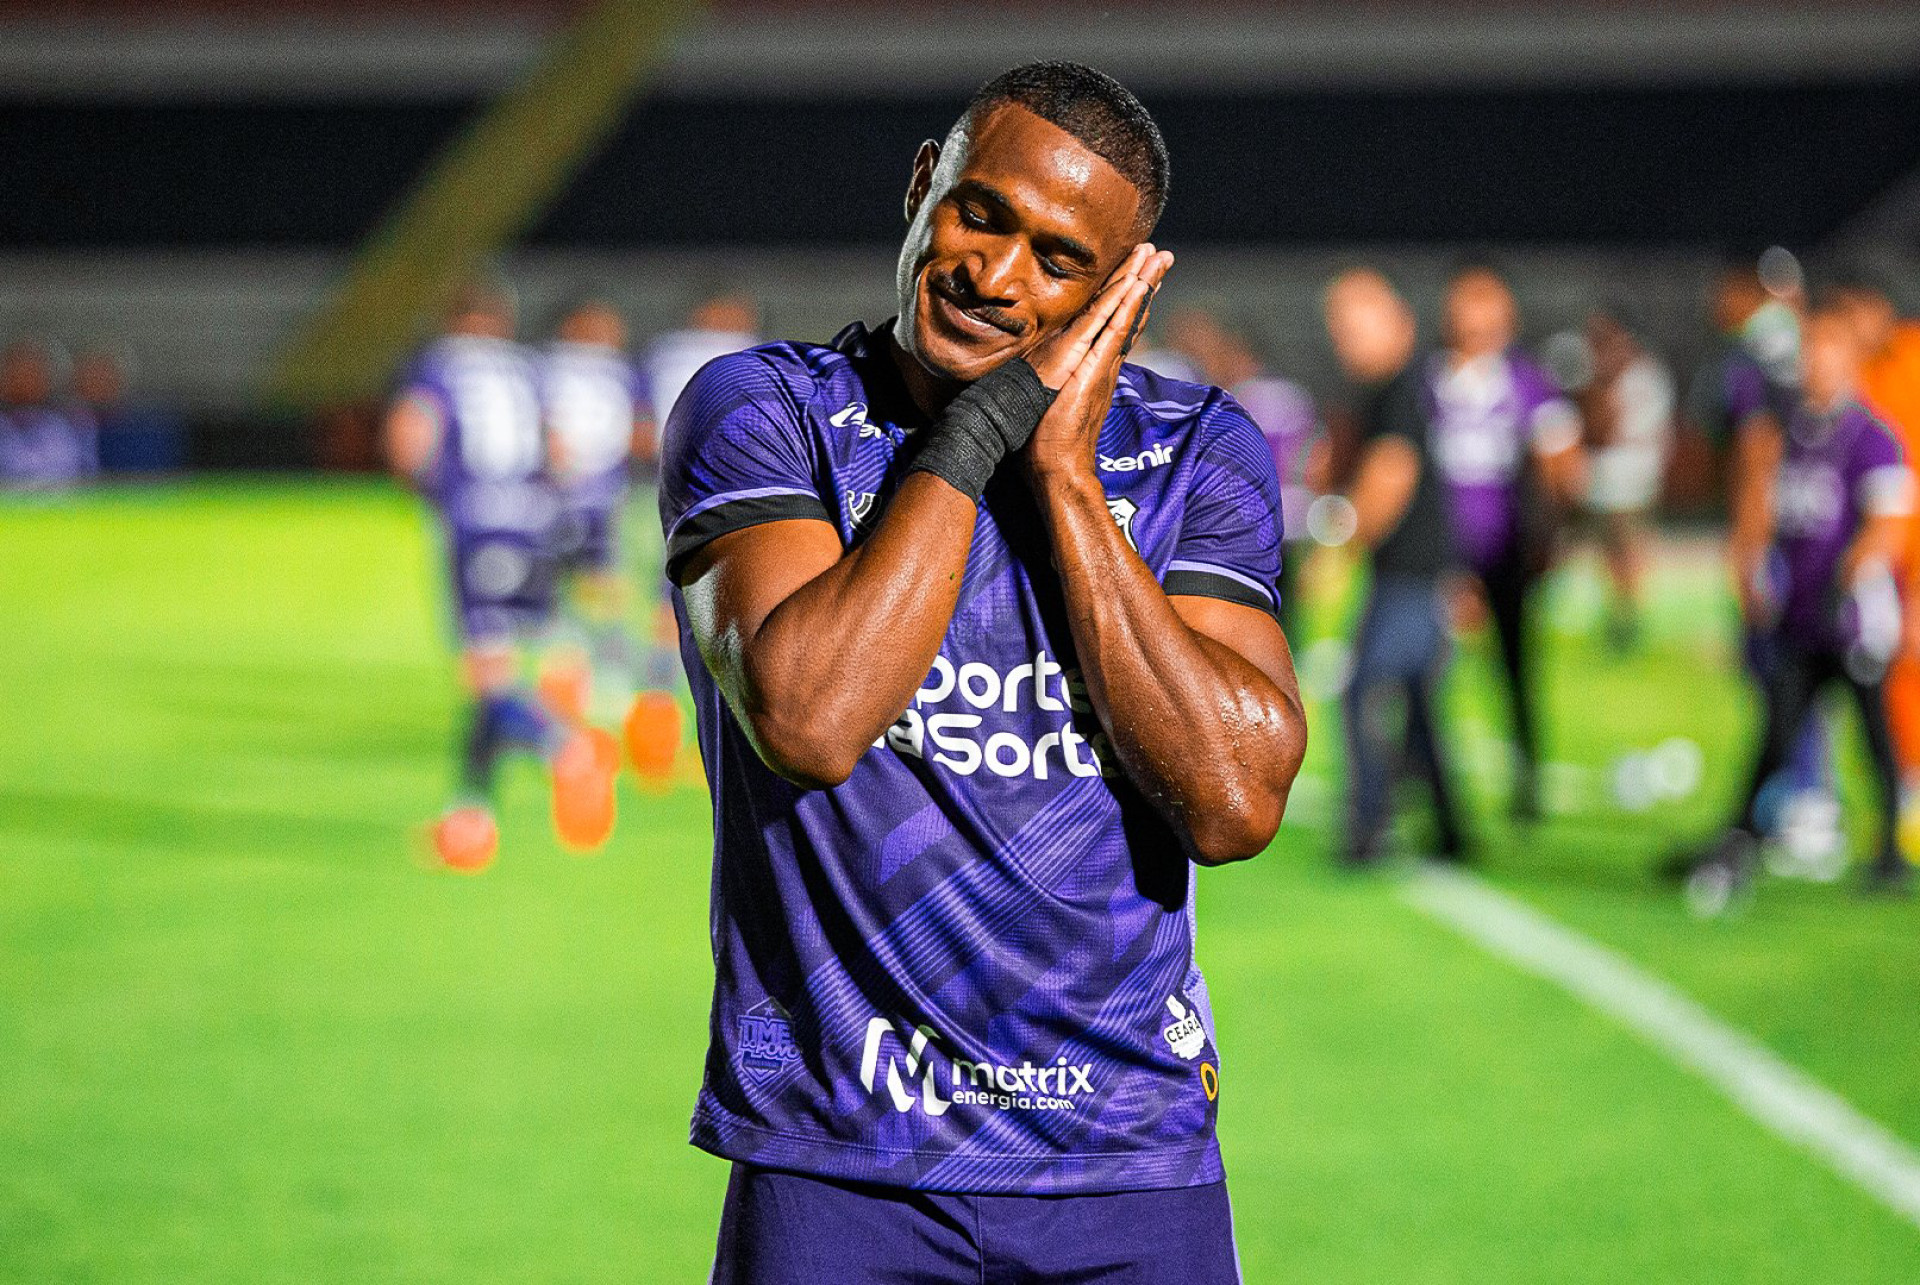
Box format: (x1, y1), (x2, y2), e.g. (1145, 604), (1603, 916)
(660, 325), (1281, 1195)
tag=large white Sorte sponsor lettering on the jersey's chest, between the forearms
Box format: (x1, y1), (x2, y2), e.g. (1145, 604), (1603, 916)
(874, 649), (1119, 780)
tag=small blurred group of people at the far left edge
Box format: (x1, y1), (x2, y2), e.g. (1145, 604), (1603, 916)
(0, 336), (186, 492)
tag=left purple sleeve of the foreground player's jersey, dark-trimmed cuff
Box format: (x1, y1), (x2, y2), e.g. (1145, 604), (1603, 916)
(660, 352), (833, 580)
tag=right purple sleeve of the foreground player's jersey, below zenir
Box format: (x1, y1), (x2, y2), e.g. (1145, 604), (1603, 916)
(1162, 394), (1286, 615)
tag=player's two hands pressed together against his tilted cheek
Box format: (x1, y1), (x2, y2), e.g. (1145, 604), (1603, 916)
(1025, 242), (1173, 471)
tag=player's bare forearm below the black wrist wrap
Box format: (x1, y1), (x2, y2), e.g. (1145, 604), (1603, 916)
(735, 473), (979, 786)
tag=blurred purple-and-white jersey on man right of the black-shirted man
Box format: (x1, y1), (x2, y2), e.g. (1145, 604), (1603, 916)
(1427, 352), (1578, 569)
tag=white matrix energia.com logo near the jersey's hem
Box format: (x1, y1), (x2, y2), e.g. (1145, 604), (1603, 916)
(860, 1018), (1092, 1116)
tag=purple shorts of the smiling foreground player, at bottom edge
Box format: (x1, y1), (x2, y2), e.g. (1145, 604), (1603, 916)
(712, 1164), (1240, 1285)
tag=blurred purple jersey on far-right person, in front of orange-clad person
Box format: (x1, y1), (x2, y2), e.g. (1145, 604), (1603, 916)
(1774, 401), (1912, 647)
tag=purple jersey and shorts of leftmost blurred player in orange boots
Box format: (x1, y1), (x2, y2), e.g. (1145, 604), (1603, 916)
(401, 334), (557, 640)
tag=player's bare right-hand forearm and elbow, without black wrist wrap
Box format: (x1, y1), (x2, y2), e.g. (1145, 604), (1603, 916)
(1035, 466), (1306, 864)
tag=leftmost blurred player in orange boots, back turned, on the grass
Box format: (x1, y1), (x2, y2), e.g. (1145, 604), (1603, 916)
(386, 284), (620, 870)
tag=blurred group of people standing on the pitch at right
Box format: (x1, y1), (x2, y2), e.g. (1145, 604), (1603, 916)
(1275, 250), (1920, 912)
